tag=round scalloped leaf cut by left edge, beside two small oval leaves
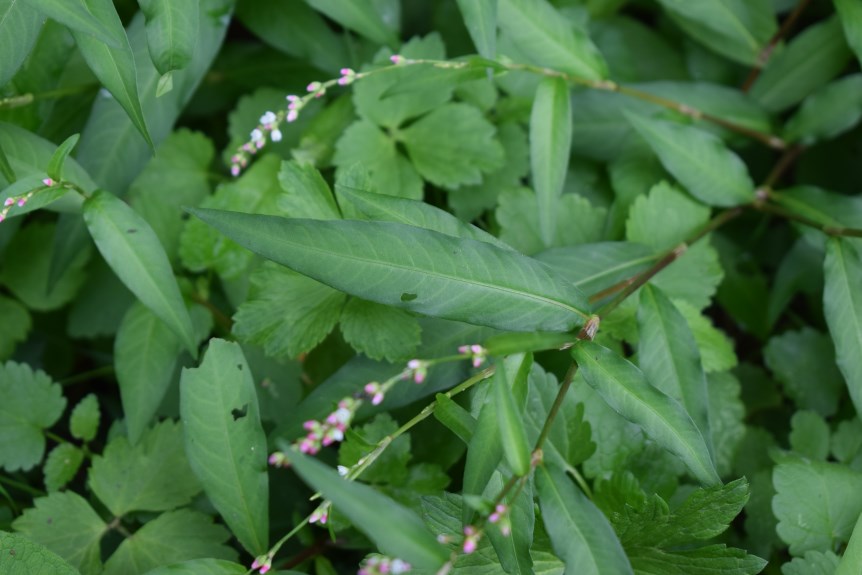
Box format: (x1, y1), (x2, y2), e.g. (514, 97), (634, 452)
(0, 361), (66, 471)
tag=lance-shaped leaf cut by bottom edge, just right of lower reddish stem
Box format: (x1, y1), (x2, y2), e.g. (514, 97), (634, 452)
(536, 465), (634, 575)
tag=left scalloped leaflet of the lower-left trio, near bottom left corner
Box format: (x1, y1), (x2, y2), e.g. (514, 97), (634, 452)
(12, 492), (108, 573)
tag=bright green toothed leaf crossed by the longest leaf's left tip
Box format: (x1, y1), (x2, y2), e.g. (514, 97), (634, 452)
(180, 155), (282, 279)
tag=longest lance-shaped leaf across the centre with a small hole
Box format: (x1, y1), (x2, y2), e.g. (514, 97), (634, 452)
(190, 209), (587, 331)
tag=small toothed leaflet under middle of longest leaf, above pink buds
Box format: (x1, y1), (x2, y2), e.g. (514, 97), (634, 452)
(341, 298), (421, 362)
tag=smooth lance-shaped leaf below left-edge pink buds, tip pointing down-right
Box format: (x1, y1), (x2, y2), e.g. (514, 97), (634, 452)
(84, 192), (197, 356)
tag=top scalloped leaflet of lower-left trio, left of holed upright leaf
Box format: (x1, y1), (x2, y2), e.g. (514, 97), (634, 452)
(89, 420), (201, 516)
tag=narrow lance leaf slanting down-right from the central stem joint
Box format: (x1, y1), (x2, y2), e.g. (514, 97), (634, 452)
(572, 341), (721, 485)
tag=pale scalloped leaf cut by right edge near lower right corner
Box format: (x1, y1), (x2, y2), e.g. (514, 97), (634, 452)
(772, 457), (862, 556)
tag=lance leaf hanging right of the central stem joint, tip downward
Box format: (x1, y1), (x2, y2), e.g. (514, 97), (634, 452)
(638, 285), (712, 462)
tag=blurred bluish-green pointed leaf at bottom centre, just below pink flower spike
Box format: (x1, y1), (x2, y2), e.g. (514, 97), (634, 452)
(282, 445), (449, 569)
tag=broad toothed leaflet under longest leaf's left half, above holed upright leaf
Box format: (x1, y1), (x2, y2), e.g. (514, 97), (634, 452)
(233, 263), (346, 357)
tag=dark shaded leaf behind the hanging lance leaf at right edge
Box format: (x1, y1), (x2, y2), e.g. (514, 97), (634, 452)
(763, 327), (844, 417)
